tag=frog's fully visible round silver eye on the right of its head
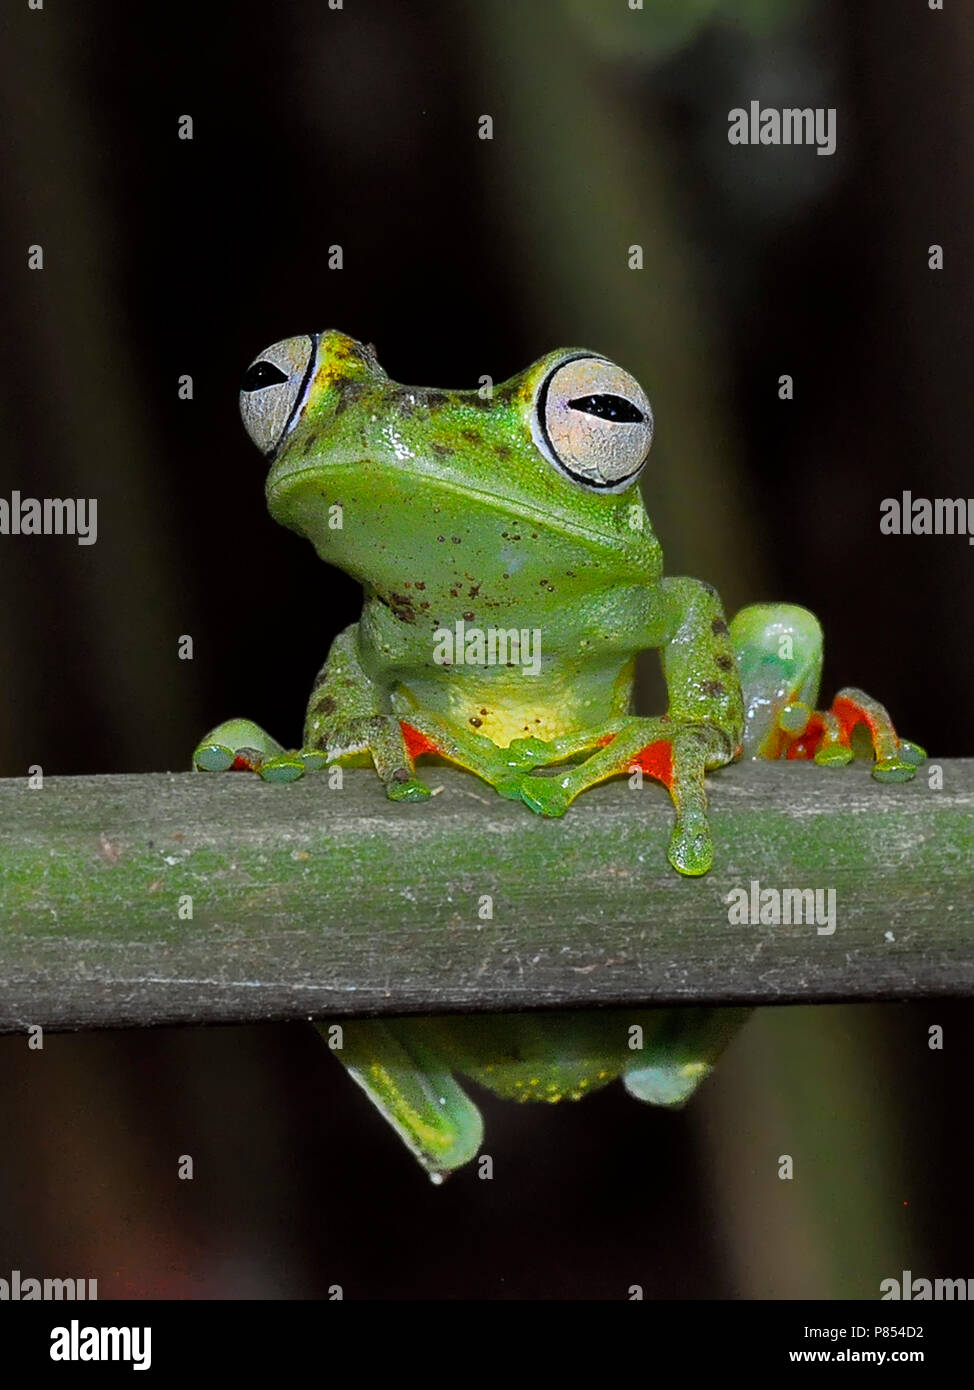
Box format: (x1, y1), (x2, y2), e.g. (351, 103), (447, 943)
(531, 353), (653, 492)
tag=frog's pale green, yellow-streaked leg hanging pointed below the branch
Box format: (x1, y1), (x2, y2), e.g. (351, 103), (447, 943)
(318, 1019), (484, 1182)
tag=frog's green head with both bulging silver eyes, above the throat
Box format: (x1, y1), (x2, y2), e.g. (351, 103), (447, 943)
(240, 331), (659, 592)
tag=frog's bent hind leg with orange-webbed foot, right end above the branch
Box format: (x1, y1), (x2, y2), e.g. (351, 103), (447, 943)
(731, 603), (925, 781)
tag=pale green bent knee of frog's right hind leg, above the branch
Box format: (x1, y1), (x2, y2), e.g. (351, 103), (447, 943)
(731, 603), (823, 758)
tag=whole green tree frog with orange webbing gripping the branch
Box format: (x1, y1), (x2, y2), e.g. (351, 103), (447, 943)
(195, 331), (924, 1179)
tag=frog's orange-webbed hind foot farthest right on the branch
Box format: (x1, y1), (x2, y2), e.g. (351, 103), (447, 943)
(778, 687), (927, 781)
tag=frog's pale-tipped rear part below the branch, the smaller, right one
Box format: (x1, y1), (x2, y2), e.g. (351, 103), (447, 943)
(622, 1009), (752, 1105)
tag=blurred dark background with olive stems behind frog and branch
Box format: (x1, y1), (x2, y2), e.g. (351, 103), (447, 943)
(0, 0), (974, 1297)
